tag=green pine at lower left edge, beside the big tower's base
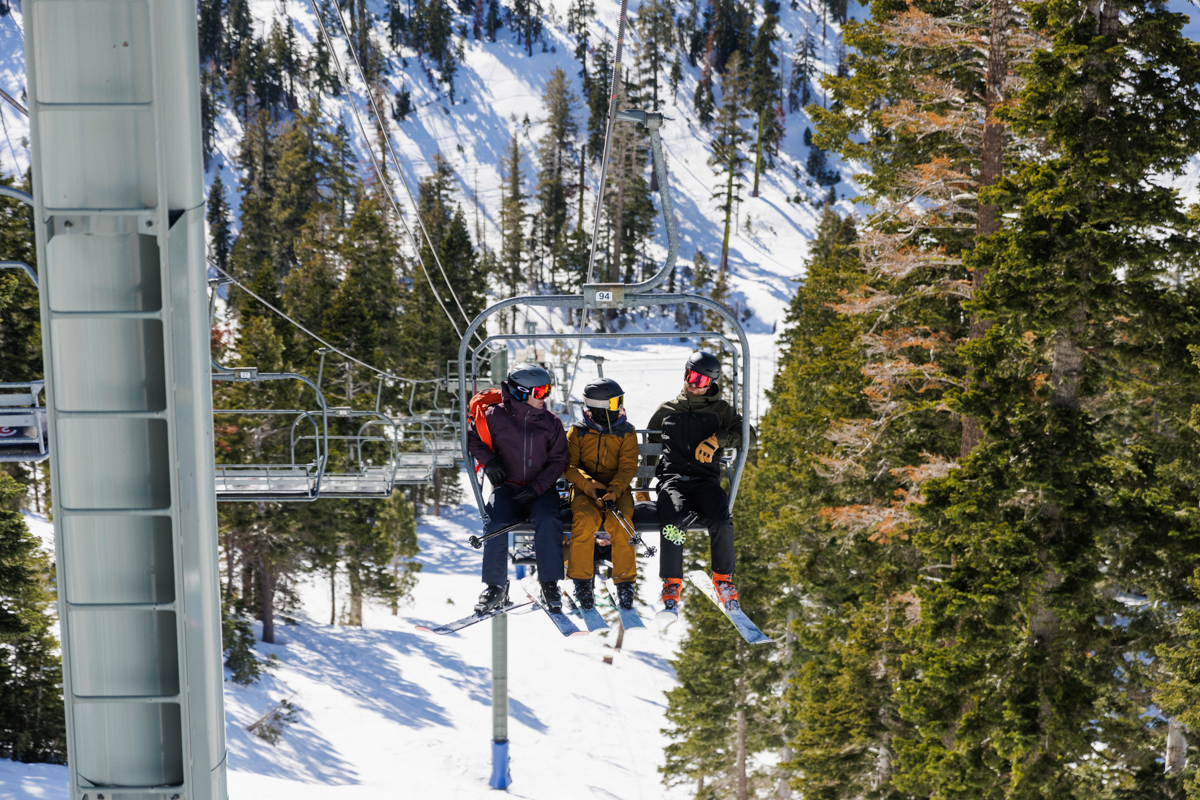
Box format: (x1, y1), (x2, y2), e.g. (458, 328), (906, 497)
(0, 474), (66, 764)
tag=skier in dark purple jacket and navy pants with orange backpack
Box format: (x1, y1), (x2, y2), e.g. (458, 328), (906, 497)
(467, 363), (568, 614)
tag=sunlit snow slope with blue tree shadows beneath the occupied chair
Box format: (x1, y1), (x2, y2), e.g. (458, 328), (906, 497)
(0, 506), (700, 800)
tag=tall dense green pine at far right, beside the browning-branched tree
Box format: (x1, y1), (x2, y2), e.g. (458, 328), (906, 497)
(901, 2), (1200, 796)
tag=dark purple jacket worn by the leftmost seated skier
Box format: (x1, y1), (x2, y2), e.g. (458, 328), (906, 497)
(467, 385), (568, 495)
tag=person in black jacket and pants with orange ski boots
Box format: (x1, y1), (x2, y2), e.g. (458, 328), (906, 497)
(649, 350), (755, 610)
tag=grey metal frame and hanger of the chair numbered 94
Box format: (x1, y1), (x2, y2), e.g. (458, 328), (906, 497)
(457, 110), (750, 537)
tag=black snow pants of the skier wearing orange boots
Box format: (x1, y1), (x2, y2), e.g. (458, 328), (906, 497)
(658, 477), (733, 581)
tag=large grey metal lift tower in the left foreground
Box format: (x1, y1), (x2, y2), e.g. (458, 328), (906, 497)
(24, 0), (226, 800)
